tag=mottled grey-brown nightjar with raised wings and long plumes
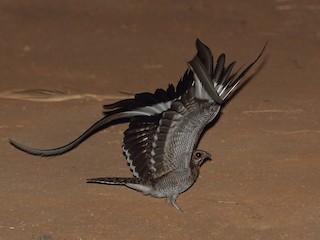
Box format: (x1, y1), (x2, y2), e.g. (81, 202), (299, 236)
(9, 39), (267, 211)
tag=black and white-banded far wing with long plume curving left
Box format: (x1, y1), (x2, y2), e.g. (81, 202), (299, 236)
(9, 67), (193, 157)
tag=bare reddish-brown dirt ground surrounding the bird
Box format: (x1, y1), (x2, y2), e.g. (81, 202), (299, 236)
(0, 0), (320, 240)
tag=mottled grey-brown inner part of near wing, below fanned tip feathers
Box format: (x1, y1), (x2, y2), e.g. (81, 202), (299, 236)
(123, 87), (220, 178)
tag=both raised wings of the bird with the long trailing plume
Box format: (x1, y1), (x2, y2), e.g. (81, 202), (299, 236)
(9, 39), (266, 159)
